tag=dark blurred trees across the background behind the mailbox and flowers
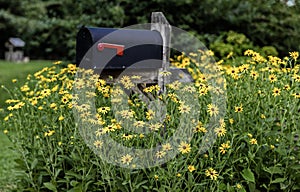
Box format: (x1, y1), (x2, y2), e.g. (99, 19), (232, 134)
(0, 0), (300, 61)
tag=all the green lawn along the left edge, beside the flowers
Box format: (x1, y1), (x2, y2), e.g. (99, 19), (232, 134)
(0, 60), (52, 192)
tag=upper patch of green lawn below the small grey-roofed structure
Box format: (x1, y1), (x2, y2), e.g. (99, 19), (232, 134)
(0, 60), (52, 108)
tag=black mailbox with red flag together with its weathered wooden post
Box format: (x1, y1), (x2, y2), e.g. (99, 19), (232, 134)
(76, 12), (192, 87)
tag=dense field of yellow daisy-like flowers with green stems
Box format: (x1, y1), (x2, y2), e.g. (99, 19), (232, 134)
(2, 50), (300, 191)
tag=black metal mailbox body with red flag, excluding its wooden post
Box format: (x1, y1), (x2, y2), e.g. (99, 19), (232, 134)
(76, 27), (163, 70)
